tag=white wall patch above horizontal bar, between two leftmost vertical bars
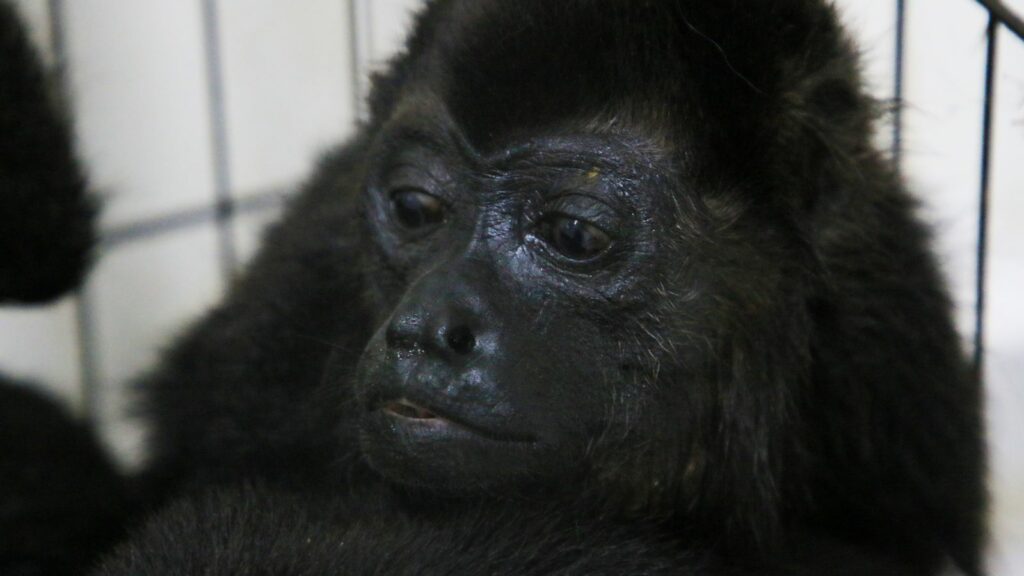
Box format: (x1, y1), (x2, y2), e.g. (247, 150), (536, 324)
(63, 0), (212, 227)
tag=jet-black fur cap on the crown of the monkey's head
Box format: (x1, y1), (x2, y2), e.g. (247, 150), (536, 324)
(385, 0), (842, 154)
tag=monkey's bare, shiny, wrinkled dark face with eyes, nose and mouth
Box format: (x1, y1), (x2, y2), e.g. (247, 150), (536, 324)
(348, 99), (692, 493)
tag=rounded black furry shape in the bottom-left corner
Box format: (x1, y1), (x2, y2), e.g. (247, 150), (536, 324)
(0, 378), (129, 576)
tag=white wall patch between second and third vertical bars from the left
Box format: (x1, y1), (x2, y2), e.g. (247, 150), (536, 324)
(219, 0), (355, 196)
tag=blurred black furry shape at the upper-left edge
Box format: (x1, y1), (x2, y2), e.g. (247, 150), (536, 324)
(0, 2), (95, 302)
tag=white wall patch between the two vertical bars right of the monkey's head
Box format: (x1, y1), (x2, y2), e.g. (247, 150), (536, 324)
(904, 0), (988, 338)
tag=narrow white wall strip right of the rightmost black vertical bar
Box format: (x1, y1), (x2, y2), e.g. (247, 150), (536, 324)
(985, 7), (1024, 575)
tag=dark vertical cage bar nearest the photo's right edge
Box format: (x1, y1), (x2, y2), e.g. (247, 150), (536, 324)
(974, 13), (999, 378)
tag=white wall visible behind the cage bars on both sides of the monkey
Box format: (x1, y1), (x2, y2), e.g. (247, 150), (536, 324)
(0, 0), (1024, 576)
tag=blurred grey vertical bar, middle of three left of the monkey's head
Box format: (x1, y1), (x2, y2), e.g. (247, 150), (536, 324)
(200, 0), (238, 281)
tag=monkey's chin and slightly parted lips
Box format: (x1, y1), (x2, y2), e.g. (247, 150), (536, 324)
(359, 405), (547, 494)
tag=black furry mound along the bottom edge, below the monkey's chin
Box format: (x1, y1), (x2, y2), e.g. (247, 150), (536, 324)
(95, 486), (906, 576)
